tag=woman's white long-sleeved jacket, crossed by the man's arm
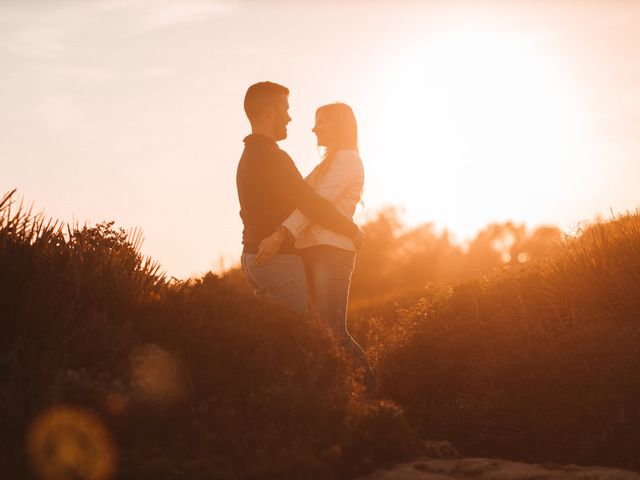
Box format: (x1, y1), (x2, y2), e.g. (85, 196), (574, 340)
(282, 149), (364, 250)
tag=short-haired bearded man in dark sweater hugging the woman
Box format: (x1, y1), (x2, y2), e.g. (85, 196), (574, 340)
(236, 82), (364, 313)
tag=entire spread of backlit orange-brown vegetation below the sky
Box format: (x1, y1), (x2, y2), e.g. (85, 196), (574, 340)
(0, 189), (640, 480)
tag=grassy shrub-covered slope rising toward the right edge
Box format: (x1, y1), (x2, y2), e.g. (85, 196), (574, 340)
(369, 209), (640, 468)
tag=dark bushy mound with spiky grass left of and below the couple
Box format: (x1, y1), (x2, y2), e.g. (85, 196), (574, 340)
(0, 191), (420, 480)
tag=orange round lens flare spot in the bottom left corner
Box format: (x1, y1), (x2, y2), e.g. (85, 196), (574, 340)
(27, 406), (117, 480)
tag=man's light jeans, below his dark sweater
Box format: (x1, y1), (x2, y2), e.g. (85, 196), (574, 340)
(240, 253), (308, 313)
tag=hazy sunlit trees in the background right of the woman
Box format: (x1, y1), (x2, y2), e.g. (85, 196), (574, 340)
(349, 209), (563, 346)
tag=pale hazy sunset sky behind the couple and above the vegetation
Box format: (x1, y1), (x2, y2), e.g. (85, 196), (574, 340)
(0, 0), (640, 277)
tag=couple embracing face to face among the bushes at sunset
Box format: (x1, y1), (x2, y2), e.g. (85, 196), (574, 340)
(236, 82), (375, 391)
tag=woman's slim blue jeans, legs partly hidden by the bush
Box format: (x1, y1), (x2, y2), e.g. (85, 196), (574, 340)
(302, 245), (370, 373)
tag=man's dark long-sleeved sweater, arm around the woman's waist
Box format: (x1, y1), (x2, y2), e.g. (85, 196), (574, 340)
(236, 134), (358, 254)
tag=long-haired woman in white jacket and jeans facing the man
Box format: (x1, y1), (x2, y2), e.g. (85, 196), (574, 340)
(258, 103), (375, 390)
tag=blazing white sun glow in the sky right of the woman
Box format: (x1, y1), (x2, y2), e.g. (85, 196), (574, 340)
(365, 24), (581, 236)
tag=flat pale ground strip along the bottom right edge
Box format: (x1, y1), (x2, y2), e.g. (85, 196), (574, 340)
(358, 457), (640, 480)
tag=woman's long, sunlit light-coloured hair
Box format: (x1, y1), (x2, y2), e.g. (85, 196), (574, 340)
(313, 102), (358, 182)
